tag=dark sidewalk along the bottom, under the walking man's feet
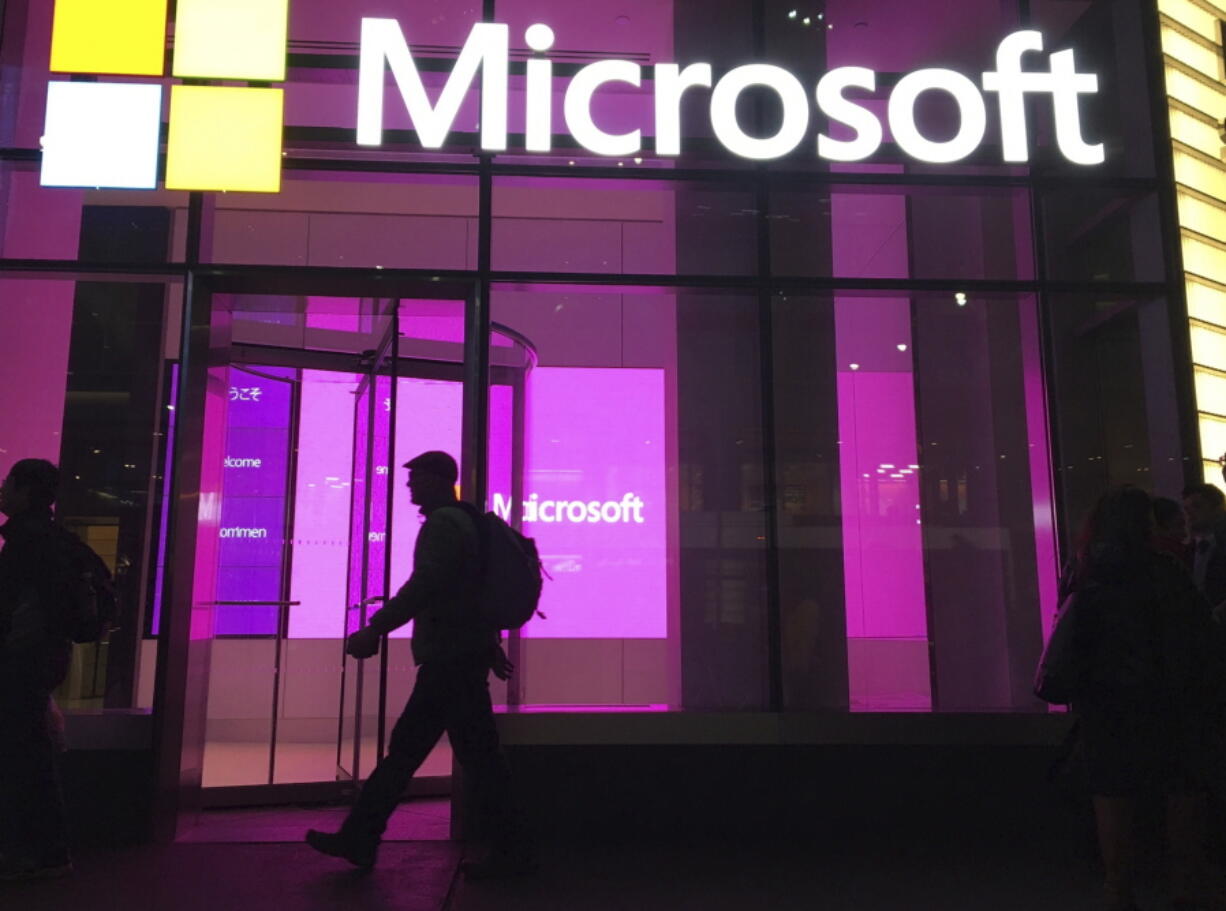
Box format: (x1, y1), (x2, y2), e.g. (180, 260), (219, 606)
(9, 802), (1216, 911)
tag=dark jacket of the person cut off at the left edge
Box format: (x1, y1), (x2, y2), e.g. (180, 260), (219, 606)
(0, 510), (72, 689)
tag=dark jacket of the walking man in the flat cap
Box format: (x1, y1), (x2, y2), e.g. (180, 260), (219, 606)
(370, 504), (499, 665)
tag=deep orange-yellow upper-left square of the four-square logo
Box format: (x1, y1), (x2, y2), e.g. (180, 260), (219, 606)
(51, 0), (167, 76)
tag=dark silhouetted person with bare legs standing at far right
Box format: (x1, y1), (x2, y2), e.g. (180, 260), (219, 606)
(1072, 488), (1224, 911)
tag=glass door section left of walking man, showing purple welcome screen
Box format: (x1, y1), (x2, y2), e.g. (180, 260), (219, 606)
(202, 293), (395, 806)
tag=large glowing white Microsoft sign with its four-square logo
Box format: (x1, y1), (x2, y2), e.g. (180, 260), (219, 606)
(40, 0), (1105, 192)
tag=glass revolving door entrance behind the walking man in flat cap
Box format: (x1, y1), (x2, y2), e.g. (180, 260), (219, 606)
(161, 288), (535, 806)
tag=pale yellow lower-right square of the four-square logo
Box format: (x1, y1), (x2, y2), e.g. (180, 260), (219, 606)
(166, 86), (284, 192)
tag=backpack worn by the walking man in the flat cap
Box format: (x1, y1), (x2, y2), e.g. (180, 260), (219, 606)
(460, 503), (544, 629)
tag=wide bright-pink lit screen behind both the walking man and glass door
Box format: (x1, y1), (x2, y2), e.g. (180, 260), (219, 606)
(289, 368), (667, 639)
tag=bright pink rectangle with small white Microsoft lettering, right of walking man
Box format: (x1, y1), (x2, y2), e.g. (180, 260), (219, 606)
(494, 368), (668, 639)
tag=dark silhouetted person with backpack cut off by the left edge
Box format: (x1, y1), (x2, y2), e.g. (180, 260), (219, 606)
(0, 459), (72, 880)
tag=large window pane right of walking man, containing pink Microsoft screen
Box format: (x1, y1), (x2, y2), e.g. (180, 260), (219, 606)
(492, 286), (766, 709)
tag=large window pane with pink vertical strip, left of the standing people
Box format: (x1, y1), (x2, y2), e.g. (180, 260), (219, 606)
(774, 292), (1056, 711)
